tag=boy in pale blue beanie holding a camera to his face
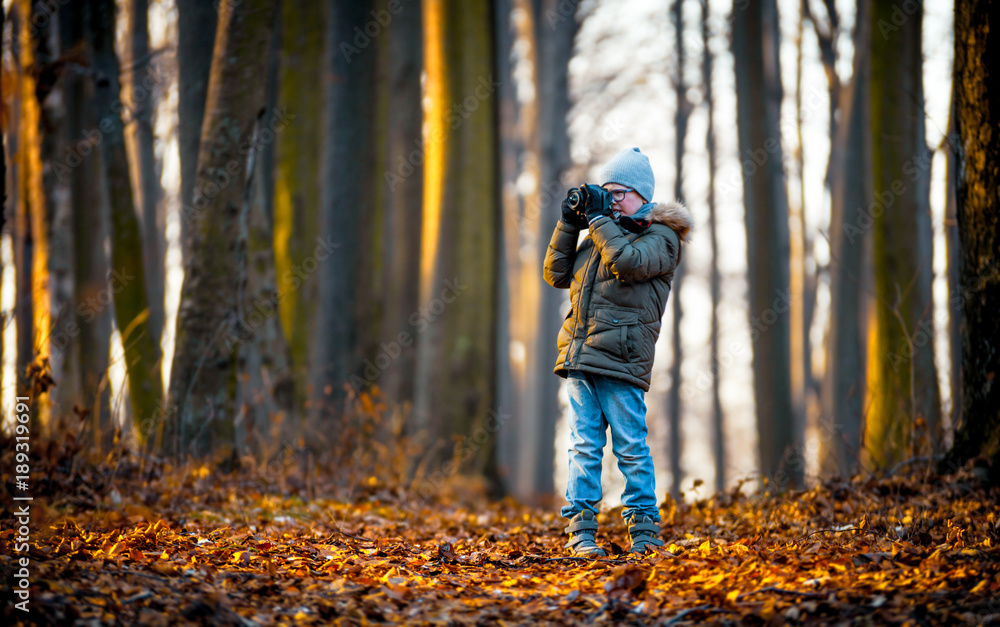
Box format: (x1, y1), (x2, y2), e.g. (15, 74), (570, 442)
(545, 148), (692, 557)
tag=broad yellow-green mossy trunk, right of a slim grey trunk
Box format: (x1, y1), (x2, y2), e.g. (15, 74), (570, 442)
(856, 1), (941, 469)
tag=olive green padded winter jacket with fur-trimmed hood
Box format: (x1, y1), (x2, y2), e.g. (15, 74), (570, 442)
(545, 202), (692, 391)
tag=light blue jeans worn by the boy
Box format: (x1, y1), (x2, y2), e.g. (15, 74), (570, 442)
(560, 370), (660, 523)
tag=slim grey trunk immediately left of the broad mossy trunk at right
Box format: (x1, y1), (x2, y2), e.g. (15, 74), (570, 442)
(819, 0), (872, 476)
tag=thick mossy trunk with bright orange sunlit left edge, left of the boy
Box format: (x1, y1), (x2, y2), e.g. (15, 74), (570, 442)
(416, 0), (502, 485)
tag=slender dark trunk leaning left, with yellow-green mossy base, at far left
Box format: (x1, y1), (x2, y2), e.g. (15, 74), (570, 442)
(91, 0), (163, 445)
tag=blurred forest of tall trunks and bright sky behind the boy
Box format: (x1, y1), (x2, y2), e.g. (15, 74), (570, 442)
(0, 0), (1000, 503)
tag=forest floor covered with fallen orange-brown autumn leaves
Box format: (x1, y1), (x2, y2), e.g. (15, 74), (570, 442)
(0, 434), (1000, 625)
